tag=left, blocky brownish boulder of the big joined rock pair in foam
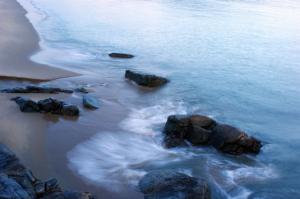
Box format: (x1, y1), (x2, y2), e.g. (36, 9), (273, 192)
(164, 115), (216, 148)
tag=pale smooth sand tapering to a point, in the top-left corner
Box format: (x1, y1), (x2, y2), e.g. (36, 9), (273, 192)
(0, 0), (78, 81)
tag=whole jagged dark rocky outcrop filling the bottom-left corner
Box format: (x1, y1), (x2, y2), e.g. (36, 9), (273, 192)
(0, 144), (94, 199)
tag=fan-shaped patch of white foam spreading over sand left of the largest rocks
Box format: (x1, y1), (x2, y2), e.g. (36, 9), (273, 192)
(68, 132), (185, 190)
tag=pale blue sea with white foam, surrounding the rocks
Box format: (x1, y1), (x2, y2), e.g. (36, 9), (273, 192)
(20, 0), (300, 199)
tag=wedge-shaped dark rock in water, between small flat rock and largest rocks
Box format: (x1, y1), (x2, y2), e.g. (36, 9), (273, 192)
(125, 70), (169, 88)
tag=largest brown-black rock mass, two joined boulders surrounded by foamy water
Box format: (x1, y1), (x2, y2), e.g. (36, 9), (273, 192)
(164, 115), (262, 155)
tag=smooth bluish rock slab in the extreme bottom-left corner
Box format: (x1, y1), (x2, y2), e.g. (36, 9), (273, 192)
(0, 173), (31, 199)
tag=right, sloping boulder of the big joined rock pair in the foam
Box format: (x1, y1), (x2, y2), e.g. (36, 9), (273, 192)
(211, 124), (262, 155)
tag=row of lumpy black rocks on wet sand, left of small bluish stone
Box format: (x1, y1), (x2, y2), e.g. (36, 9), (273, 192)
(12, 97), (79, 116)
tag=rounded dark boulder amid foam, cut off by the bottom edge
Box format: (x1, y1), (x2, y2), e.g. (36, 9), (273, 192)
(139, 170), (211, 199)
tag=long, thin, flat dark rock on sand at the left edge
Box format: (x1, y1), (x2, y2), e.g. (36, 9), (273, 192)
(1, 85), (73, 94)
